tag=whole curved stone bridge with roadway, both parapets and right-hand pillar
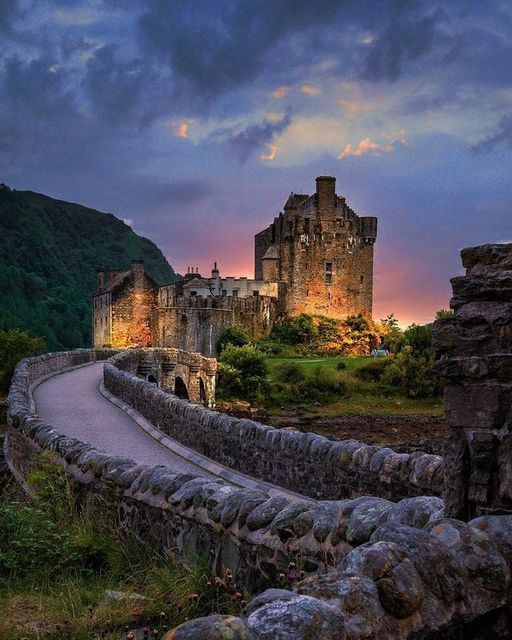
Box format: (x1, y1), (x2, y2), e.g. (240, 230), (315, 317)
(5, 245), (512, 640)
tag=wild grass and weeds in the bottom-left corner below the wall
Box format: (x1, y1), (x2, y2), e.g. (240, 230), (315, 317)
(0, 456), (244, 640)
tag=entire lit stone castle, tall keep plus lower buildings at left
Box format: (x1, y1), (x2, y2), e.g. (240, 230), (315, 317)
(93, 176), (377, 356)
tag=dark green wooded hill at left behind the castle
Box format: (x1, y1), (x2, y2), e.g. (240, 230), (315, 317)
(0, 185), (176, 350)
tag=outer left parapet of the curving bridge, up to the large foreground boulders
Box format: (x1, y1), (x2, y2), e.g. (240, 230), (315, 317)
(6, 350), (442, 593)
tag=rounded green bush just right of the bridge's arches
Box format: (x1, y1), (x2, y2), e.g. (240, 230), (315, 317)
(219, 344), (268, 399)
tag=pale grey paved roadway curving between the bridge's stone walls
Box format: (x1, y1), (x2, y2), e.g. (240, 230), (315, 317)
(34, 362), (212, 477)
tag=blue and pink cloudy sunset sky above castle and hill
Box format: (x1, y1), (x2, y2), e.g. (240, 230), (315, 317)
(0, 0), (512, 325)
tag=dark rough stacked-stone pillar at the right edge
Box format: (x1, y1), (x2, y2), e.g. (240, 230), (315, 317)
(434, 244), (512, 519)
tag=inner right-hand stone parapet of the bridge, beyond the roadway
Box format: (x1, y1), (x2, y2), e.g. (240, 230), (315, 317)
(104, 350), (444, 500)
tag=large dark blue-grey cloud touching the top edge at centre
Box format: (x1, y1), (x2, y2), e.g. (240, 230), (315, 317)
(140, 0), (341, 104)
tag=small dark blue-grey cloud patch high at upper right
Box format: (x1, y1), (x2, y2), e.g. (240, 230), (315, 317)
(363, 12), (442, 82)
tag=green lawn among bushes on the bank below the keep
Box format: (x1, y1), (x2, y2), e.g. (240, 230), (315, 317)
(266, 356), (444, 417)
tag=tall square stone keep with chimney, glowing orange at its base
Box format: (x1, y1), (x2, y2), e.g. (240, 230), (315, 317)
(254, 176), (377, 318)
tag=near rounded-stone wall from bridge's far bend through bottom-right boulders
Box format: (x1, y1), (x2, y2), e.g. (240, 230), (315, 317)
(7, 340), (512, 640)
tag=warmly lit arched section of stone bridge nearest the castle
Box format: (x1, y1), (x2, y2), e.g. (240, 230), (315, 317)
(132, 348), (217, 408)
